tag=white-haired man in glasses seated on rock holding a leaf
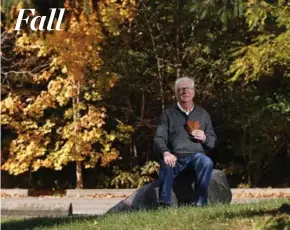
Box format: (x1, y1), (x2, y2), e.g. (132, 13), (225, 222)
(154, 77), (216, 206)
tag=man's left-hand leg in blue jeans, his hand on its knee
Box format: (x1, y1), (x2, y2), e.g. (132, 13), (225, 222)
(159, 160), (185, 205)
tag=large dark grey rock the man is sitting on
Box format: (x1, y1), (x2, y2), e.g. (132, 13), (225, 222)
(108, 169), (232, 213)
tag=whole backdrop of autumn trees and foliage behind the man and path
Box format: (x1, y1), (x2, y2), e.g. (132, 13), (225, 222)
(1, 0), (290, 188)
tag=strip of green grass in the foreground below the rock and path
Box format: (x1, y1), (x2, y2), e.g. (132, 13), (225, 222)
(1, 199), (290, 230)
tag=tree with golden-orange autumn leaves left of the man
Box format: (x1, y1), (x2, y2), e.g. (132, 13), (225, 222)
(1, 1), (137, 188)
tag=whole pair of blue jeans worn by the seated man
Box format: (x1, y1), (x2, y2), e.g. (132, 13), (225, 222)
(159, 153), (213, 206)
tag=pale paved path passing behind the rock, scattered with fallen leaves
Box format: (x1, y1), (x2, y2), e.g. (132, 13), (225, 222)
(1, 188), (290, 215)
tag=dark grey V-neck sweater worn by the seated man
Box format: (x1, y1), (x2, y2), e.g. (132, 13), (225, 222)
(154, 105), (216, 157)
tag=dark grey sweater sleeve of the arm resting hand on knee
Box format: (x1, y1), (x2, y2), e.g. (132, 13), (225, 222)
(154, 113), (170, 156)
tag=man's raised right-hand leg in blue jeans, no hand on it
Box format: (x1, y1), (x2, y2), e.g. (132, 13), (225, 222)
(188, 153), (213, 206)
